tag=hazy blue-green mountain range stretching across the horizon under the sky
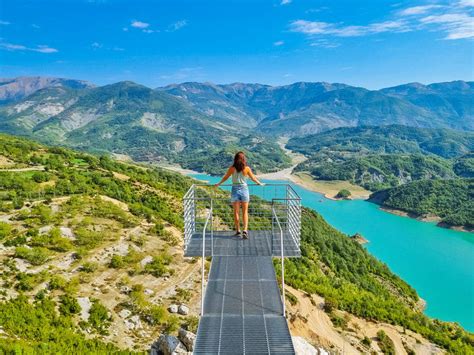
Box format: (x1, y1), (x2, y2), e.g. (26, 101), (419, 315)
(0, 77), (474, 171)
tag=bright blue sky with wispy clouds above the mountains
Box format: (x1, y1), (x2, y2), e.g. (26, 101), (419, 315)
(0, 0), (474, 89)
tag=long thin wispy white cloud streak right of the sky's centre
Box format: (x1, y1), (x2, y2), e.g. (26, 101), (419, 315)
(290, 20), (409, 37)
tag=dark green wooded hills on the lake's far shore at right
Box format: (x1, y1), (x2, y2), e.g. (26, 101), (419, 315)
(287, 125), (474, 229)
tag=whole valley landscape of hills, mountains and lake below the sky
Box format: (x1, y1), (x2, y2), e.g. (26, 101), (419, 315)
(0, 78), (474, 353)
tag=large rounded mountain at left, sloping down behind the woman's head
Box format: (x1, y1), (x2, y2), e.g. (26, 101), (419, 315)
(0, 82), (288, 172)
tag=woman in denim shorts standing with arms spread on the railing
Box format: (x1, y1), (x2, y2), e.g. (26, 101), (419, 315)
(215, 152), (263, 239)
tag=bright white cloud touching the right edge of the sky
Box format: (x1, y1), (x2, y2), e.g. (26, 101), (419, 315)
(420, 13), (474, 40)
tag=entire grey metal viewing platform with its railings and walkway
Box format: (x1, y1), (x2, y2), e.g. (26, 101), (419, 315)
(183, 184), (301, 354)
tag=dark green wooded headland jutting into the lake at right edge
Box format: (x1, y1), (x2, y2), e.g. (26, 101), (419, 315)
(371, 179), (474, 229)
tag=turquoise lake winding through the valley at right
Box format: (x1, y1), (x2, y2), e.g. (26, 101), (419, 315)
(191, 174), (474, 332)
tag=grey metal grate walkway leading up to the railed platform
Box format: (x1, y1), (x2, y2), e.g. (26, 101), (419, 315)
(194, 256), (295, 354)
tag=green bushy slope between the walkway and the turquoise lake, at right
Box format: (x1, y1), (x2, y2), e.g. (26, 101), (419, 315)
(280, 209), (474, 354)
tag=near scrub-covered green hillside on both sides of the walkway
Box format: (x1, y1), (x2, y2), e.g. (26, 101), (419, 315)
(0, 135), (474, 354)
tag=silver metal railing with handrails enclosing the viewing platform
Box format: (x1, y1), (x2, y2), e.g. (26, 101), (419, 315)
(183, 184), (301, 316)
